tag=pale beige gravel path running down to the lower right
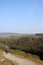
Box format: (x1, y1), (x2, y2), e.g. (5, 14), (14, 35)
(4, 52), (39, 65)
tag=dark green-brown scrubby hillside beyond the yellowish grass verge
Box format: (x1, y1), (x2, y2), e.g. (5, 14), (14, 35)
(0, 36), (43, 60)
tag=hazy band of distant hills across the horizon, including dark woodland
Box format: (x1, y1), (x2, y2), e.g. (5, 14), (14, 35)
(0, 33), (43, 37)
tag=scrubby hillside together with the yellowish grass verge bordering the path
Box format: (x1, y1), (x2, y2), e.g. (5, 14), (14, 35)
(0, 35), (43, 63)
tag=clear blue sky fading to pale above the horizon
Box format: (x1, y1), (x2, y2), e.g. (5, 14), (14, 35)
(0, 0), (43, 34)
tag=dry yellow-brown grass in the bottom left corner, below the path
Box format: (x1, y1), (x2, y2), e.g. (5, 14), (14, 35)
(0, 50), (18, 65)
